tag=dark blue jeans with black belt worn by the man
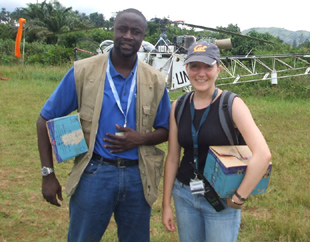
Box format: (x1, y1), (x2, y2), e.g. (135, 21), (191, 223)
(68, 160), (151, 242)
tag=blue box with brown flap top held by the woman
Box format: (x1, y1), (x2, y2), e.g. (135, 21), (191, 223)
(204, 145), (272, 198)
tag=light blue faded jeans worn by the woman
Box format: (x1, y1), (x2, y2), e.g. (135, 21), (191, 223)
(172, 180), (241, 242)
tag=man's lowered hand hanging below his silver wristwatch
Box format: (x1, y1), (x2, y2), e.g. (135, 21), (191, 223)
(42, 174), (63, 207)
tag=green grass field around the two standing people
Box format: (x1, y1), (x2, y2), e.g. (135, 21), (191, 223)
(0, 66), (310, 242)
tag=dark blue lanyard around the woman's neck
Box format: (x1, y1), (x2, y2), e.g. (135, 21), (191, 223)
(190, 88), (218, 170)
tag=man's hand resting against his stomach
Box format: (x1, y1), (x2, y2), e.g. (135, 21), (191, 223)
(103, 124), (142, 153)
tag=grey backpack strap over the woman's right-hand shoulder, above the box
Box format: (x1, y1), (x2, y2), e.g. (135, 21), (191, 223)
(219, 90), (239, 145)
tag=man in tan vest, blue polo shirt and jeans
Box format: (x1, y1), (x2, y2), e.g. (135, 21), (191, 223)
(37, 9), (170, 242)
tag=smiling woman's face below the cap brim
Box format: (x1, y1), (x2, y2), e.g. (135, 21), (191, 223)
(186, 62), (221, 91)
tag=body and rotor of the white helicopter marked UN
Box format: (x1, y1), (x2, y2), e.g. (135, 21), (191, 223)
(75, 19), (290, 91)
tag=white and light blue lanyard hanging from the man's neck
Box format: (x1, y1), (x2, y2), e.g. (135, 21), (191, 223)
(107, 61), (137, 127)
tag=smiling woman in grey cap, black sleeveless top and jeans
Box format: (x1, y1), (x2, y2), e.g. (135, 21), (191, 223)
(162, 42), (271, 242)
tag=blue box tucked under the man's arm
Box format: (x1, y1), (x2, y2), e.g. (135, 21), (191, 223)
(46, 114), (88, 162)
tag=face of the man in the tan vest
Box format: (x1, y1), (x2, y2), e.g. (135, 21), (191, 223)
(114, 13), (146, 58)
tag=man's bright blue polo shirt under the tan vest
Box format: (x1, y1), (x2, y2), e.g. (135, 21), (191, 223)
(41, 53), (171, 160)
